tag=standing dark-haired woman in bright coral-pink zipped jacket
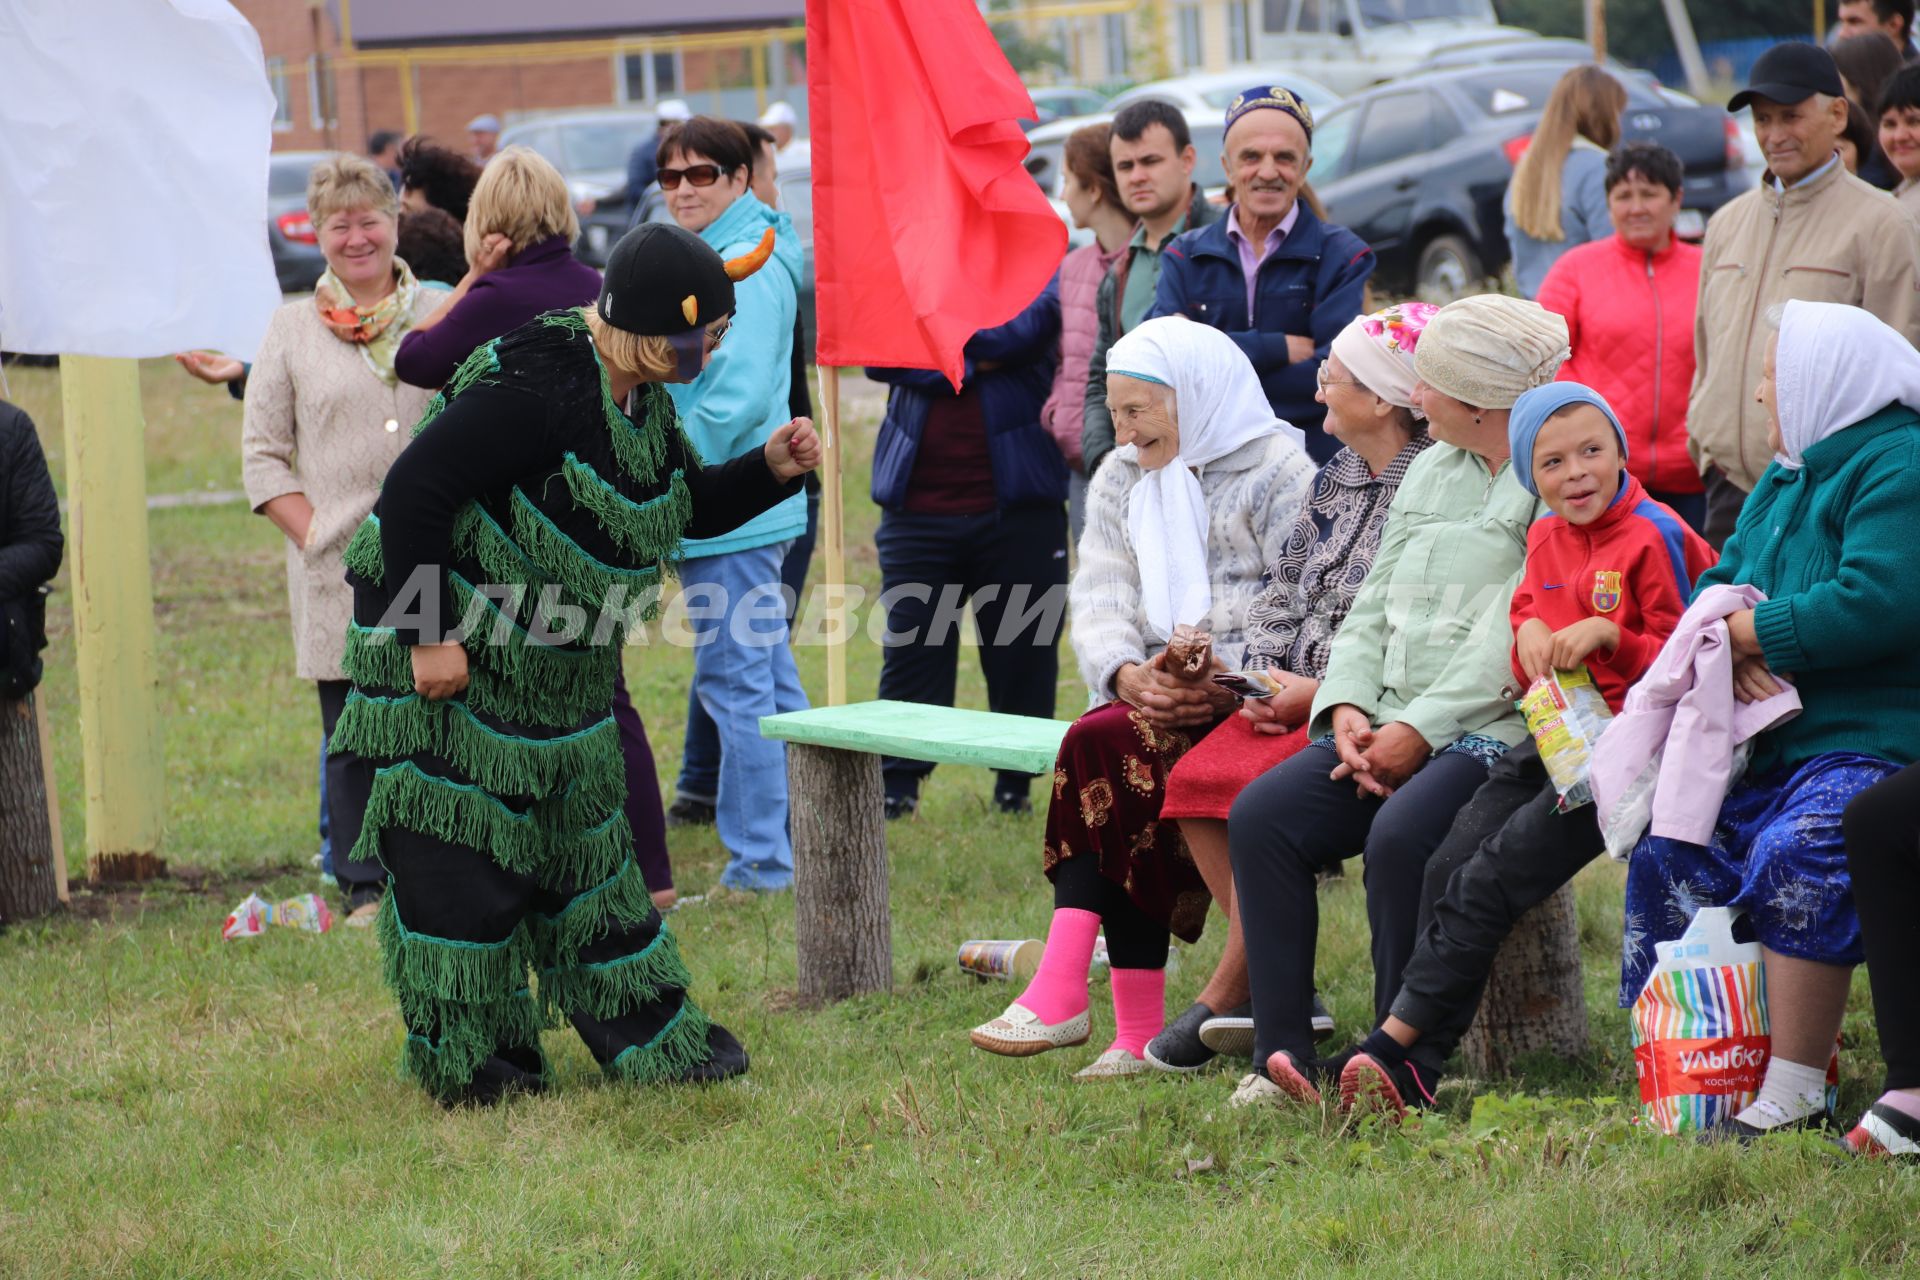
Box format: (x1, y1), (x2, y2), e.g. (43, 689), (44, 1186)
(1540, 142), (1707, 530)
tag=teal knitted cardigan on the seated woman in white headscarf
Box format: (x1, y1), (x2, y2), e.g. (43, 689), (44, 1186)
(1697, 405), (1920, 773)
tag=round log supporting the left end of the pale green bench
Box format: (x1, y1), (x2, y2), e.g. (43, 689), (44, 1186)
(787, 743), (893, 1004)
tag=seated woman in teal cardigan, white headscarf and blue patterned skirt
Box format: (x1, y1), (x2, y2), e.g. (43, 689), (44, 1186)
(1620, 301), (1920, 1140)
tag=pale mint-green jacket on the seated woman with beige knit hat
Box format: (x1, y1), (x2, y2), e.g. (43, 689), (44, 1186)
(1311, 445), (1544, 750)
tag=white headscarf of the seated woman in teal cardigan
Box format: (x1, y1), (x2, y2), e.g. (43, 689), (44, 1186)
(1774, 301), (1920, 470)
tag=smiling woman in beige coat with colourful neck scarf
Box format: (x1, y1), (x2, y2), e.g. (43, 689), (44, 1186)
(240, 155), (440, 925)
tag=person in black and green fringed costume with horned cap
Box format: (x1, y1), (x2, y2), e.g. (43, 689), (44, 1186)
(332, 225), (820, 1105)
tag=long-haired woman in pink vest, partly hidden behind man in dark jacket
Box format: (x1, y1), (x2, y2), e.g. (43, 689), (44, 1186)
(1041, 125), (1133, 547)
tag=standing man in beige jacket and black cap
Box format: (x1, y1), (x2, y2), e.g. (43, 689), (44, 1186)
(1688, 44), (1920, 547)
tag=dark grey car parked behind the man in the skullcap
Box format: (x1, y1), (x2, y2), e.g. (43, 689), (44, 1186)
(1311, 61), (1753, 301)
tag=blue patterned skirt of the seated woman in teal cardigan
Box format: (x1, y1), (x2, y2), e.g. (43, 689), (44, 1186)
(1620, 750), (1901, 1009)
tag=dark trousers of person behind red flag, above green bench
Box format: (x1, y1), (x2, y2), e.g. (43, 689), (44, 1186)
(874, 503), (1068, 798)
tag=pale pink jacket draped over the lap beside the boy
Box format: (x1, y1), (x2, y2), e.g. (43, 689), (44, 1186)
(1592, 585), (1801, 844)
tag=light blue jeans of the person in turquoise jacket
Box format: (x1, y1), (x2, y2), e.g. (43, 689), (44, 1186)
(680, 543), (806, 889)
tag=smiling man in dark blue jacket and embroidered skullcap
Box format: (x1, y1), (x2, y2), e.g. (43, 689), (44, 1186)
(1152, 84), (1375, 462)
